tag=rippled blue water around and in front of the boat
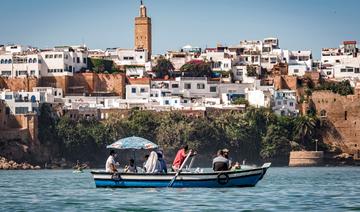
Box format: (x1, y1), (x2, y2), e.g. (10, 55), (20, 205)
(0, 167), (360, 211)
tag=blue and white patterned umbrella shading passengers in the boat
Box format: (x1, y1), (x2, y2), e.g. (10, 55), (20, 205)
(106, 136), (158, 150)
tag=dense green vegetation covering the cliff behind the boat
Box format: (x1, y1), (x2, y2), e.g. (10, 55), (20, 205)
(40, 104), (321, 166)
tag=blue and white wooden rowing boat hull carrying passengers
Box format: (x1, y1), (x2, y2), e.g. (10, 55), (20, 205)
(91, 163), (271, 188)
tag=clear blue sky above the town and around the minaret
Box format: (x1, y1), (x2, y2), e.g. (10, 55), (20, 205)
(0, 0), (360, 58)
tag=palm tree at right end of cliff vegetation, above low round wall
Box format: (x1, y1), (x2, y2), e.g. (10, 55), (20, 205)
(294, 116), (318, 145)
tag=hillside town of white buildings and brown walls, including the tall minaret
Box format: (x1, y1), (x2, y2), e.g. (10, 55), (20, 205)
(0, 4), (360, 167)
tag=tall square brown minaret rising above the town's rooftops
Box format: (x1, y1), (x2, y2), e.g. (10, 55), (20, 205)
(135, 0), (152, 59)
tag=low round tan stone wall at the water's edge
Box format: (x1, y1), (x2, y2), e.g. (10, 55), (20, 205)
(289, 151), (324, 166)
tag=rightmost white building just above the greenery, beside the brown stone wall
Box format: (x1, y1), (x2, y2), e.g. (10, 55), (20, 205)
(272, 90), (299, 116)
